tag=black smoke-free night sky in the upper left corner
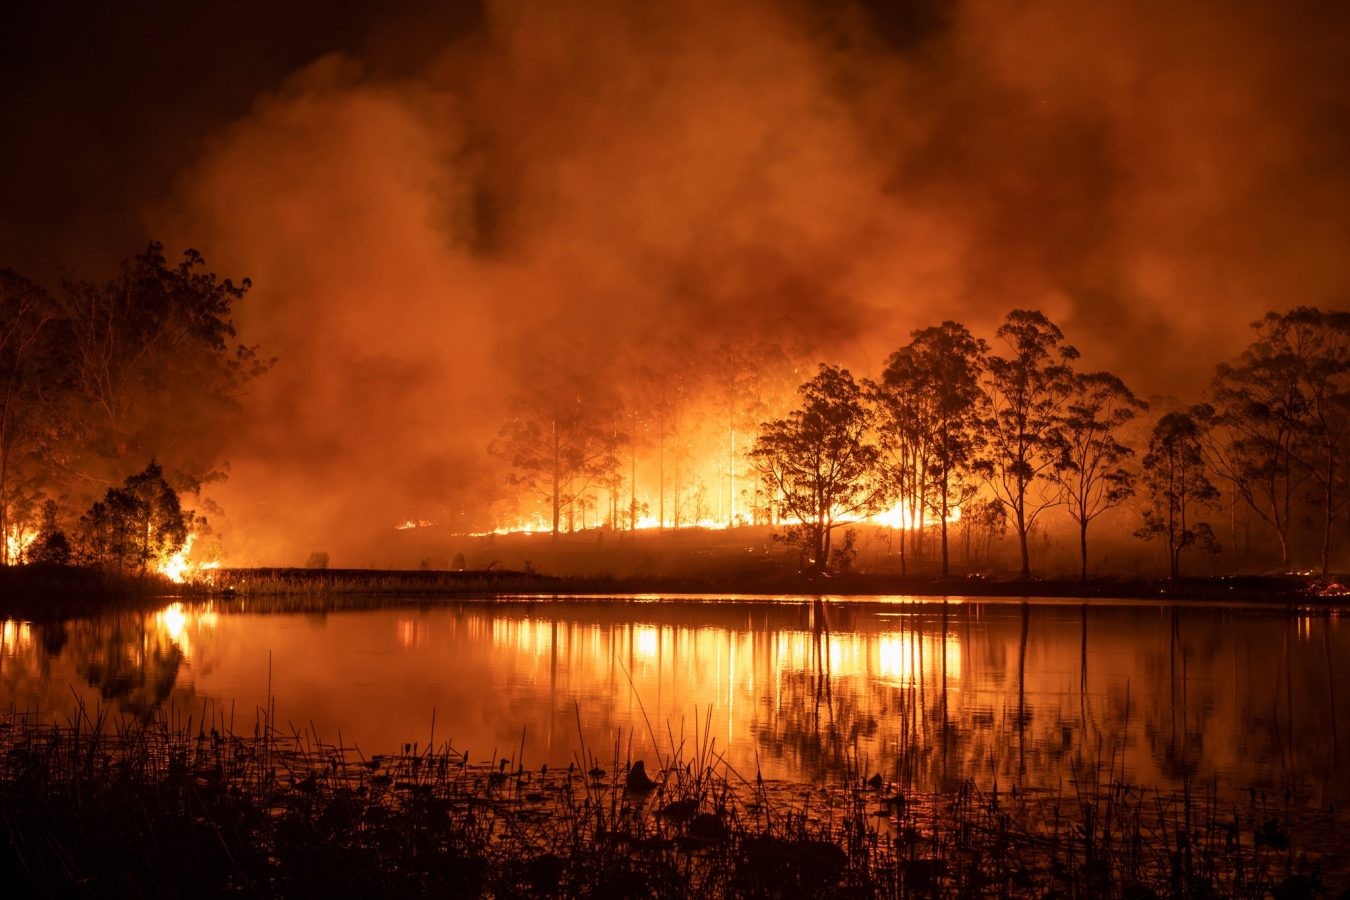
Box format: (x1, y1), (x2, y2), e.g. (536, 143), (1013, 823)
(0, 0), (481, 275)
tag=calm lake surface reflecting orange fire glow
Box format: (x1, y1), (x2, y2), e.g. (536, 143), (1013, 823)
(0, 599), (1350, 808)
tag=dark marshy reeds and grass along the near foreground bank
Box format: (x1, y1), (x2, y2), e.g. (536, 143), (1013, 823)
(0, 708), (1347, 897)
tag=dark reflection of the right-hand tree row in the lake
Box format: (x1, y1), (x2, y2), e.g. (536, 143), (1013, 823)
(734, 603), (1347, 801)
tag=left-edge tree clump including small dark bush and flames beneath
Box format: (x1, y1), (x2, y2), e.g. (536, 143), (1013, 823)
(0, 243), (271, 575)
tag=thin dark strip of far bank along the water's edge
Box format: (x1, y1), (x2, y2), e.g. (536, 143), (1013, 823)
(0, 565), (1350, 618)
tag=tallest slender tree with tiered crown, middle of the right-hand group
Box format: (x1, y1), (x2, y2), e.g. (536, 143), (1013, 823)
(976, 309), (1079, 578)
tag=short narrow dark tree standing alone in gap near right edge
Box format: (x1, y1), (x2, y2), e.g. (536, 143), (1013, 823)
(1135, 413), (1219, 578)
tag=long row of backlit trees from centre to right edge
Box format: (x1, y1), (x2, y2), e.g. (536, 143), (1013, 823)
(491, 306), (1350, 578)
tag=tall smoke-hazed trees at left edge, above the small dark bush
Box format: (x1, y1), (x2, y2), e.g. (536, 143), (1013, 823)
(0, 243), (273, 563)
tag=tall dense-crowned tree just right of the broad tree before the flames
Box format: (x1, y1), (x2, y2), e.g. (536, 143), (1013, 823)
(871, 321), (988, 576)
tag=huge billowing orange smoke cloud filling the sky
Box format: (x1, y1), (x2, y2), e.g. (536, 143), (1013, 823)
(159, 0), (1350, 565)
